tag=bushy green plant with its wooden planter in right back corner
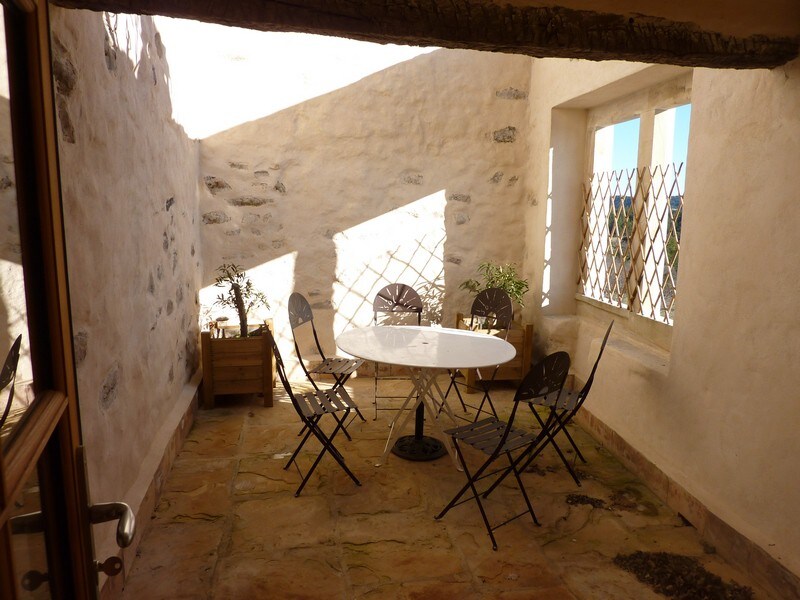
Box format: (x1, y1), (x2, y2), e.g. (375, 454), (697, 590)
(456, 261), (533, 384)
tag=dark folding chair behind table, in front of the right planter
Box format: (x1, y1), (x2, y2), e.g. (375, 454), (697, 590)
(444, 288), (514, 421)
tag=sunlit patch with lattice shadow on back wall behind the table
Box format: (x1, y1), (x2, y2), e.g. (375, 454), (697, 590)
(333, 190), (447, 333)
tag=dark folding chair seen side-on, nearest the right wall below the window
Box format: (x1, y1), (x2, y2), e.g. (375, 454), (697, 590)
(522, 321), (614, 485)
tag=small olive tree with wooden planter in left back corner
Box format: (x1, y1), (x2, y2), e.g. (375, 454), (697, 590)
(200, 264), (275, 408)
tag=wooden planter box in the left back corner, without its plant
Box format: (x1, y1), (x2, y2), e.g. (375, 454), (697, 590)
(200, 331), (275, 408)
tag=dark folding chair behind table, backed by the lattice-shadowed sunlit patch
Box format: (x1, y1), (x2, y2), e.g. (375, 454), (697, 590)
(372, 283), (422, 420)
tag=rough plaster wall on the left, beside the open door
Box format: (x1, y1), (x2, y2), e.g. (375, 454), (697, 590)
(51, 7), (200, 560)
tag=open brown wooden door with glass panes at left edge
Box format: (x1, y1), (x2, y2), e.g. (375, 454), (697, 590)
(0, 0), (103, 600)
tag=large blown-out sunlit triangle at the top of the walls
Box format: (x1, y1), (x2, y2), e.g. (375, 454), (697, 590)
(154, 17), (436, 139)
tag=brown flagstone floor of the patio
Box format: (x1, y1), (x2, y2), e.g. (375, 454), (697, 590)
(123, 379), (769, 600)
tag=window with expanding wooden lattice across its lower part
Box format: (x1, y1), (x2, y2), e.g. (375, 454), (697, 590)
(580, 104), (691, 325)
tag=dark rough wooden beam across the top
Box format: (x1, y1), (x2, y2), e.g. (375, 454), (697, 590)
(55, 0), (800, 69)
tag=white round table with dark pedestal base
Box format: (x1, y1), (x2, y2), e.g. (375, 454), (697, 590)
(336, 325), (516, 464)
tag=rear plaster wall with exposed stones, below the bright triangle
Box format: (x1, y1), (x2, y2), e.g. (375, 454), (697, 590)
(195, 50), (530, 370)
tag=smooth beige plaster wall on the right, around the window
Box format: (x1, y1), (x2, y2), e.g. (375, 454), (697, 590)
(528, 56), (800, 573)
